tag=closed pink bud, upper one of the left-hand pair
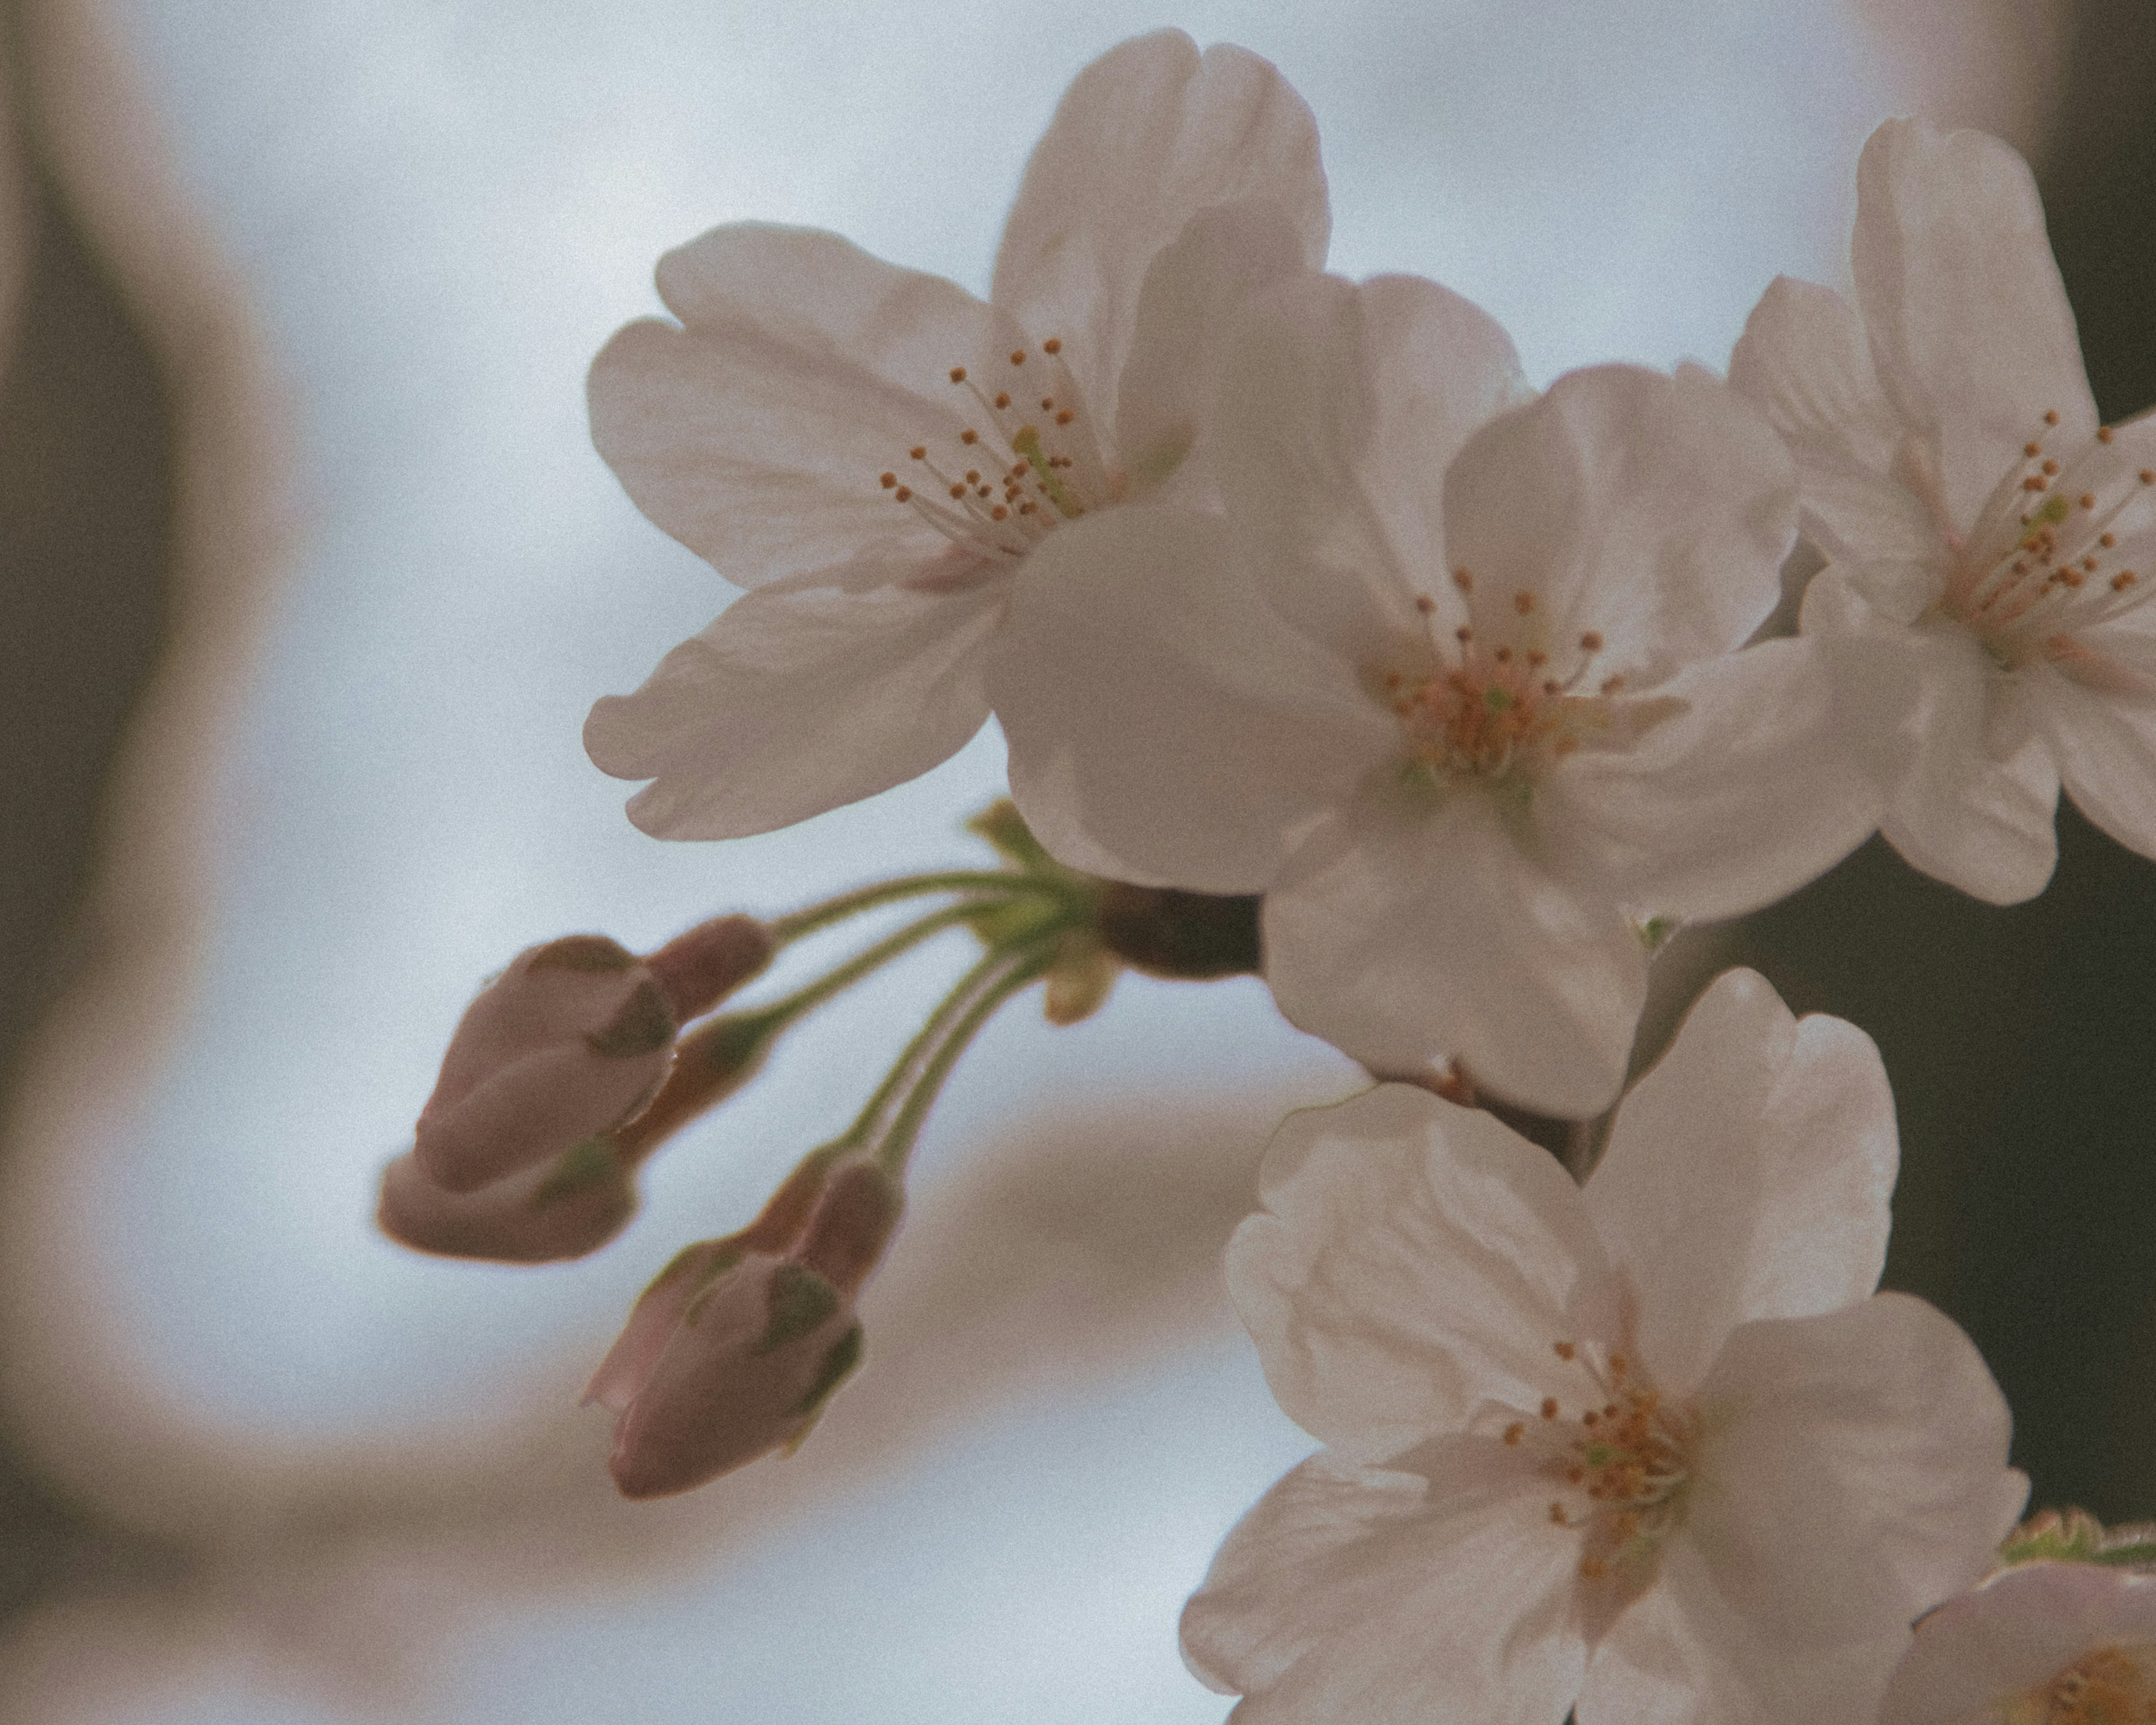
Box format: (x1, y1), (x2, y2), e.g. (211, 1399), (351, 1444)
(414, 934), (675, 1193)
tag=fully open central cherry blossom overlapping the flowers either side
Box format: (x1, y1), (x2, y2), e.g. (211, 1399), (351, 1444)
(990, 276), (1876, 1117)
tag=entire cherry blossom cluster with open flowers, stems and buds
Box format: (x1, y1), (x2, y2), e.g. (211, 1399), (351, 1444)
(382, 30), (2156, 1725)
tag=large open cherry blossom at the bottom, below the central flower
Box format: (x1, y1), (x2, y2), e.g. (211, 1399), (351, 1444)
(1184, 970), (2027, 1725)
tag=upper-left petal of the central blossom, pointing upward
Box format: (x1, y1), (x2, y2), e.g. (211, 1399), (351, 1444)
(1212, 276), (1533, 670)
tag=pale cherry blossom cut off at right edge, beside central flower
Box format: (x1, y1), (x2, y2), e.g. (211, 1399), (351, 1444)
(1732, 121), (2156, 903)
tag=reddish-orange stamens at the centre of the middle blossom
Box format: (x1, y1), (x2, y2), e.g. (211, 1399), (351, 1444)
(1384, 569), (1624, 781)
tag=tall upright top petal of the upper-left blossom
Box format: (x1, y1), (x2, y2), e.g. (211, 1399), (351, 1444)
(990, 30), (1332, 425)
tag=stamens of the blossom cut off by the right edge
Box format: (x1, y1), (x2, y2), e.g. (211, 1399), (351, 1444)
(1940, 412), (2156, 668)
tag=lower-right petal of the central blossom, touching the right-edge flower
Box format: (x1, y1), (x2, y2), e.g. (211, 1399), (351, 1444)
(1535, 640), (1880, 919)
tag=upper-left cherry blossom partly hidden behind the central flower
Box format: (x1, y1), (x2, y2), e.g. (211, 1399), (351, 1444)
(584, 30), (1330, 839)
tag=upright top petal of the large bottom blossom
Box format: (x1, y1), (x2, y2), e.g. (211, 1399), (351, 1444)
(1587, 970), (1899, 1395)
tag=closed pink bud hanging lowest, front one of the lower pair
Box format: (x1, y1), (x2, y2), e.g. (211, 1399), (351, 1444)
(593, 1248), (860, 1499)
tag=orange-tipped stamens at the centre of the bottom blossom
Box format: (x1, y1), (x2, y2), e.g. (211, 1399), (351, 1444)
(1505, 1341), (1699, 1581)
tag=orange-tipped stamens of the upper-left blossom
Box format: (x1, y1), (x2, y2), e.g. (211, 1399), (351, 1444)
(880, 341), (1119, 559)
